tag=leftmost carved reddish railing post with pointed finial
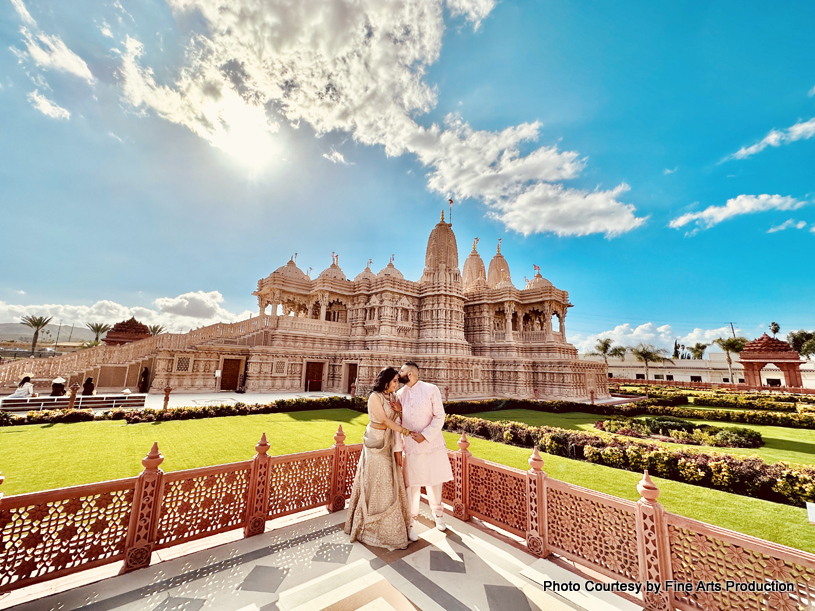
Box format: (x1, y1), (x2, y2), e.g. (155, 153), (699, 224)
(119, 442), (164, 574)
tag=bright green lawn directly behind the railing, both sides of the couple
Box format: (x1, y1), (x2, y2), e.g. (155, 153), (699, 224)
(0, 410), (815, 552)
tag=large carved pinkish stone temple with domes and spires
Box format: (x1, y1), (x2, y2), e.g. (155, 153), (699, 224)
(145, 213), (608, 399)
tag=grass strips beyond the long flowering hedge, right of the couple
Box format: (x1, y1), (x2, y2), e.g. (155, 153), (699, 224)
(472, 409), (815, 465)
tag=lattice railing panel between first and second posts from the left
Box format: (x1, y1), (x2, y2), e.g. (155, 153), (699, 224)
(156, 465), (250, 547)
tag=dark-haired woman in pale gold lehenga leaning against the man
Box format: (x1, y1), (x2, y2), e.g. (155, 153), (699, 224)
(345, 367), (410, 550)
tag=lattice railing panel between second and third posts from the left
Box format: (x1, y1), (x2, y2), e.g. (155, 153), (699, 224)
(269, 450), (332, 518)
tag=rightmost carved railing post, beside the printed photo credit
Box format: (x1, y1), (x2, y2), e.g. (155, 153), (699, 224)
(637, 469), (674, 611)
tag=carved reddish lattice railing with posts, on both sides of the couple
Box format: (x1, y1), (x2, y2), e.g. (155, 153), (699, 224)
(0, 427), (815, 611)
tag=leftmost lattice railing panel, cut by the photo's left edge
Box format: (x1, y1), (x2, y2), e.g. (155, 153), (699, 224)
(0, 478), (136, 591)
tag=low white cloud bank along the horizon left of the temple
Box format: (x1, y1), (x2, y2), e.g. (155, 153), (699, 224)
(0, 291), (254, 333)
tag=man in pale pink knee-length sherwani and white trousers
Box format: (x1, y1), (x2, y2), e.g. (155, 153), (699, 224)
(397, 361), (453, 541)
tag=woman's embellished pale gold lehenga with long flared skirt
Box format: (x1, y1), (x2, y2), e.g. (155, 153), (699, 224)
(345, 397), (410, 550)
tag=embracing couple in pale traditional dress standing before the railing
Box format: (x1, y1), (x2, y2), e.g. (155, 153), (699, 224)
(345, 362), (453, 550)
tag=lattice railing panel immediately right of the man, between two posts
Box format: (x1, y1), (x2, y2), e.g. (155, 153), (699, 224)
(467, 460), (527, 536)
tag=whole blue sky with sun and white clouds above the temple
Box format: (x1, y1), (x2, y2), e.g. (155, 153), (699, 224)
(0, 0), (815, 350)
